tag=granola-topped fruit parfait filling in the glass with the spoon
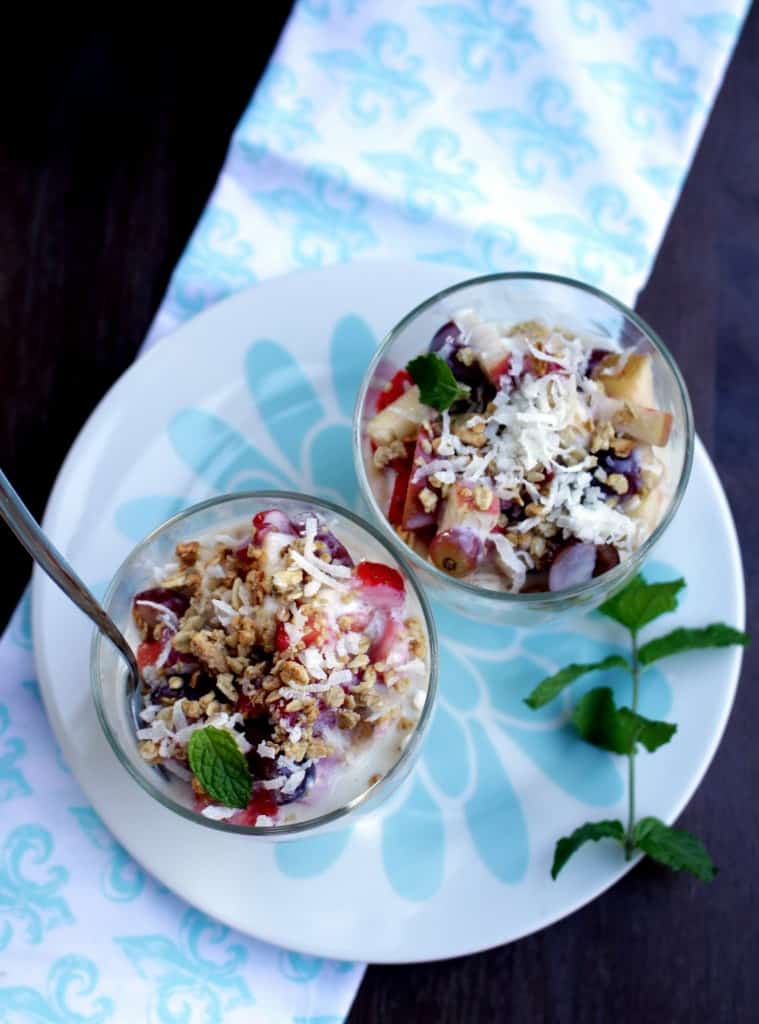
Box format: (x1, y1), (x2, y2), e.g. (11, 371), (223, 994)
(131, 499), (430, 828)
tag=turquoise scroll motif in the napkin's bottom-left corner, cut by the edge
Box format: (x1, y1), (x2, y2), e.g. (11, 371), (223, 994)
(0, 955), (114, 1024)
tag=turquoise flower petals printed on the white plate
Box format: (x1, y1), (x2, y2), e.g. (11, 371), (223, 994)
(112, 316), (670, 901)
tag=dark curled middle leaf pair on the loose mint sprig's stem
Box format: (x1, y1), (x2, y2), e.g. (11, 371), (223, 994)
(572, 686), (677, 754)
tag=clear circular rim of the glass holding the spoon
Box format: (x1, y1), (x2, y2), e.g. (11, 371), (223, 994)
(90, 490), (438, 839)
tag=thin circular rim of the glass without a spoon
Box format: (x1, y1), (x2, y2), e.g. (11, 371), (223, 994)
(353, 271), (694, 607)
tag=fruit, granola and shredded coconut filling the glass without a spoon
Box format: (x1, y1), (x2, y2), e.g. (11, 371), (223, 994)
(365, 308), (673, 594)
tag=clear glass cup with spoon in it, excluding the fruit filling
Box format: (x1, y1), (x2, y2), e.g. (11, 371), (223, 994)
(90, 490), (437, 840)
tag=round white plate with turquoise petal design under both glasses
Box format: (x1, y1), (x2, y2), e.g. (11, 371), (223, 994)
(33, 263), (744, 962)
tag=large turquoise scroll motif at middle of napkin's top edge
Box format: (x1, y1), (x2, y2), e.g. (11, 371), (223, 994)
(421, 0), (541, 82)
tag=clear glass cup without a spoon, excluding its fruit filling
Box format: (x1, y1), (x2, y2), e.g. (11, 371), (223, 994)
(353, 273), (693, 626)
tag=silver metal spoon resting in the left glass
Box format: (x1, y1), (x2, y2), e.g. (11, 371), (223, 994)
(0, 469), (142, 729)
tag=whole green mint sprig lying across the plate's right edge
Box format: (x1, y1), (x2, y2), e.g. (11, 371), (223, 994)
(524, 575), (749, 882)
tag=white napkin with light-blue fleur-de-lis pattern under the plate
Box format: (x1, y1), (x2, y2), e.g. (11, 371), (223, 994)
(0, 0), (748, 1024)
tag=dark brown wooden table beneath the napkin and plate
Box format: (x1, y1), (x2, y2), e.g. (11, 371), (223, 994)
(0, 9), (759, 1024)
